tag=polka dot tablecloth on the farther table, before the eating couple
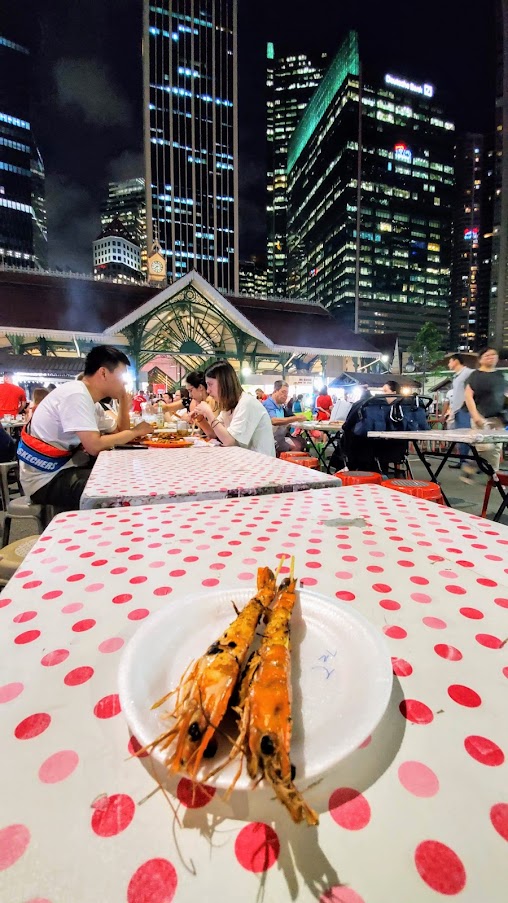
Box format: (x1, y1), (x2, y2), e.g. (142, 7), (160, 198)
(81, 445), (340, 509)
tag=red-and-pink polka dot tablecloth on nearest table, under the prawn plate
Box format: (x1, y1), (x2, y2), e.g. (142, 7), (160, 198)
(0, 488), (508, 903)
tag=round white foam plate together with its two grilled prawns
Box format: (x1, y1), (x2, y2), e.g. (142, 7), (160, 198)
(119, 567), (392, 824)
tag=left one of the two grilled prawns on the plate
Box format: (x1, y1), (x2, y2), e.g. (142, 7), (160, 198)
(147, 568), (275, 778)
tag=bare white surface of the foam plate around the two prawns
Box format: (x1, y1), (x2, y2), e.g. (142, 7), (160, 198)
(119, 587), (392, 790)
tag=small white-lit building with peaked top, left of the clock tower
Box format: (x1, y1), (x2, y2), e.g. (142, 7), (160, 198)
(93, 218), (144, 282)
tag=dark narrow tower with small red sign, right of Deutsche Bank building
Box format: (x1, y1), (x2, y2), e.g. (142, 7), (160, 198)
(450, 134), (493, 351)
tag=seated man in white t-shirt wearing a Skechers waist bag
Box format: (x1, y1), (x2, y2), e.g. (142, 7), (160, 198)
(18, 345), (152, 511)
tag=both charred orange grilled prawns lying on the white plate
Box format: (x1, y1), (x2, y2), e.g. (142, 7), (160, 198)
(140, 559), (319, 825)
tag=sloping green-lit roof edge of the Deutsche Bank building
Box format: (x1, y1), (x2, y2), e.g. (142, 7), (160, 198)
(287, 31), (360, 173)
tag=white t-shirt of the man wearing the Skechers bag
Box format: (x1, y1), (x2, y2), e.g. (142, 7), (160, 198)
(19, 380), (116, 496)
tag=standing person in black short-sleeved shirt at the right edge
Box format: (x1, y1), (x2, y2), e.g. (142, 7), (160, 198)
(461, 348), (506, 483)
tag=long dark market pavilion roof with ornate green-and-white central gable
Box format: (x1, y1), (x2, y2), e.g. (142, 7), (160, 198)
(0, 269), (379, 372)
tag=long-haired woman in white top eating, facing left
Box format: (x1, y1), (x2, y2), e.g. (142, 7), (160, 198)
(192, 361), (275, 457)
